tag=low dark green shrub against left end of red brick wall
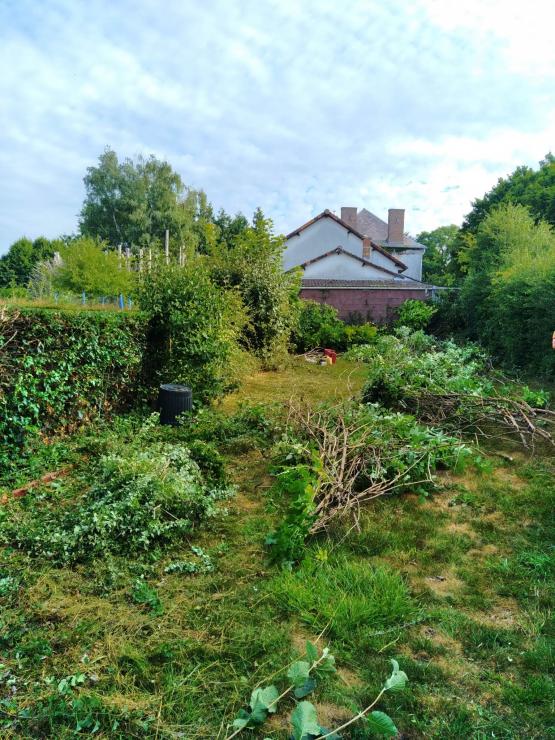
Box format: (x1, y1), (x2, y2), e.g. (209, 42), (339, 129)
(292, 301), (377, 352)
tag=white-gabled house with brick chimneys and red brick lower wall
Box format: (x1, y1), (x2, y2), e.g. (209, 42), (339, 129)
(283, 207), (432, 323)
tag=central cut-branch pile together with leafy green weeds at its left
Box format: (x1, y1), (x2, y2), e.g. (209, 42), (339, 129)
(266, 401), (472, 567)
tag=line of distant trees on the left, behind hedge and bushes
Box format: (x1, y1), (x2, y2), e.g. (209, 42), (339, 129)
(0, 148), (249, 292)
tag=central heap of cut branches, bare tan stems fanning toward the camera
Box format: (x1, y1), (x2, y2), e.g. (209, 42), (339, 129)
(282, 402), (472, 534)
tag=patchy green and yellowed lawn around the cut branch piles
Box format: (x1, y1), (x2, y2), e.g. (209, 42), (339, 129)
(0, 361), (555, 740)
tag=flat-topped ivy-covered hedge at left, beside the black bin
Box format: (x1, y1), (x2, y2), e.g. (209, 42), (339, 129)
(0, 308), (146, 467)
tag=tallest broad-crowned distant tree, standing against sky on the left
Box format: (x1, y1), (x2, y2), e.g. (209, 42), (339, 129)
(79, 148), (198, 252)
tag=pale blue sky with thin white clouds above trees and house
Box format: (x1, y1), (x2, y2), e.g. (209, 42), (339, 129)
(0, 0), (555, 253)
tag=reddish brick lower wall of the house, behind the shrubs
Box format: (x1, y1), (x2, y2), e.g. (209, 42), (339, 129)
(300, 288), (429, 324)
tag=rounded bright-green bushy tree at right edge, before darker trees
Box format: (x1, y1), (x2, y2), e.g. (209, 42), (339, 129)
(458, 204), (555, 375)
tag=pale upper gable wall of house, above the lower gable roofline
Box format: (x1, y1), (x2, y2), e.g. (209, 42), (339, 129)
(283, 218), (364, 278)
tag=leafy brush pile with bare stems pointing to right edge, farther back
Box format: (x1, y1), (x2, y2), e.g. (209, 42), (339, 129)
(353, 332), (555, 447)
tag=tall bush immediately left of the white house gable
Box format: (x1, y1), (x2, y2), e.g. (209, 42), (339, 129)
(211, 210), (298, 367)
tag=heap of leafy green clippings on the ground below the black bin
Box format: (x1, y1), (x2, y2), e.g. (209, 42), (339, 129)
(0, 424), (231, 564)
